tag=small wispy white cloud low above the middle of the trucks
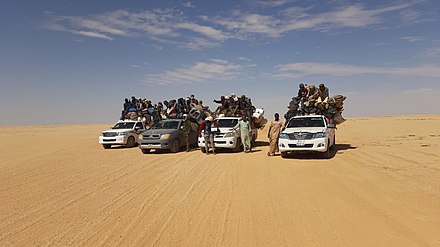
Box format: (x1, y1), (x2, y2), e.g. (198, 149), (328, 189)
(144, 59), (245, 85)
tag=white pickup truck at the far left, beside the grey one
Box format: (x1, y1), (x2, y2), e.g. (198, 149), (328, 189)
(99, 121), (145, 149)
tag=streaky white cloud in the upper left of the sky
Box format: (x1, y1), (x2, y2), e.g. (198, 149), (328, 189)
(45, 9), (229, 48)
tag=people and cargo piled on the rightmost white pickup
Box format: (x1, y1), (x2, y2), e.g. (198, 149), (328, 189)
(284, 83), (346, 124)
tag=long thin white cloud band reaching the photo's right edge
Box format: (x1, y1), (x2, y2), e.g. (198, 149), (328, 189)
(273, 62), (440, 78)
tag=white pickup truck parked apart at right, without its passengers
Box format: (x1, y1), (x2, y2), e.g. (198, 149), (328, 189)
(278, 115), (336, 158)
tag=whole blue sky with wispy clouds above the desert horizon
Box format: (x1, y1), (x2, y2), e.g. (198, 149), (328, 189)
(0, 0), (440, 125)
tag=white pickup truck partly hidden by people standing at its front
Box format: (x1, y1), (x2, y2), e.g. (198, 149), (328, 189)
(198, 117), (258, 153)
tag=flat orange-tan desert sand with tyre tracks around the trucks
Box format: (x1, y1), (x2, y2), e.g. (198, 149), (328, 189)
(0, 115), (440, 246)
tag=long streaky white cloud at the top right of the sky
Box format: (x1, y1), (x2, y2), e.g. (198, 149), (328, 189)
(212, 4), (411, 38)
